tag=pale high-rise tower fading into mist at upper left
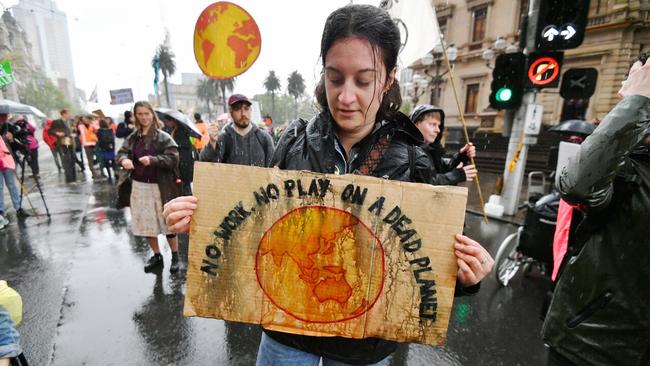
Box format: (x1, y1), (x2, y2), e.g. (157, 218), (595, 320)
(12, 0), (77, 102)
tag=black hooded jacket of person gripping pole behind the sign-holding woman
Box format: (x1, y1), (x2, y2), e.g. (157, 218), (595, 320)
(410, 104), (470, 185)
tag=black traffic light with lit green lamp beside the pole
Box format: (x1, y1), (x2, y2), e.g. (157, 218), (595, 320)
(490, 52), (526, 109)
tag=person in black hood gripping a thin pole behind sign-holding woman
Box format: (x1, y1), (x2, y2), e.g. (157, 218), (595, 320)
(410, 104), (477, 185)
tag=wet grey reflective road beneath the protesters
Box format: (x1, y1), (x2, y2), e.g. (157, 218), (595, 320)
(0, 153), (549, 366)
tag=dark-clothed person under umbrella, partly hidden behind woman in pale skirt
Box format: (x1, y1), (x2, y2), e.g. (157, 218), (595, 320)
(163, 115), (197, 195)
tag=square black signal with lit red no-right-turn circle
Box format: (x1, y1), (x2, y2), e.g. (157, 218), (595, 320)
(526, 52), (563, 89)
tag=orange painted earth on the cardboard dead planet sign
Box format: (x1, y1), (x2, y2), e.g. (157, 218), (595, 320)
(256, 206), (384, 323)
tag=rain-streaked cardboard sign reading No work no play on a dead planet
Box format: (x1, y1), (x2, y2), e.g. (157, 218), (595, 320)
(184, 163), (467, 345)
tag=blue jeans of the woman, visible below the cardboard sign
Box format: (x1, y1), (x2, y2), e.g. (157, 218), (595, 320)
(256, 333), (388, 366)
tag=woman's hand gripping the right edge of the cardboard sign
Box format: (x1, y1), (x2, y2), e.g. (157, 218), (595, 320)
(454, 234), (494, 287)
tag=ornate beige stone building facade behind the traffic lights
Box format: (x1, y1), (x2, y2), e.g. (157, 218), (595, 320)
(407, 0), (650, 137)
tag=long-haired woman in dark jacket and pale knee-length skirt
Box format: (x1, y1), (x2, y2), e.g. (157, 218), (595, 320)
(117, 101), (180, 273)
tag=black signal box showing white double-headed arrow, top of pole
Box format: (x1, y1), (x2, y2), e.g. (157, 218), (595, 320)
(529, 0), (589, 51)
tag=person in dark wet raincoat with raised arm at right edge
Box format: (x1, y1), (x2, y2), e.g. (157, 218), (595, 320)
(542, 54), (650, 366)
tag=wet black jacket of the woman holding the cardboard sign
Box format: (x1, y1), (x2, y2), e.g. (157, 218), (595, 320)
(264, 112), (470, 365)
